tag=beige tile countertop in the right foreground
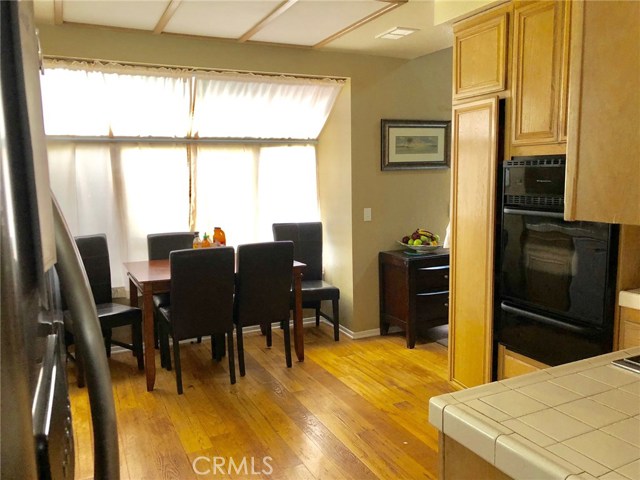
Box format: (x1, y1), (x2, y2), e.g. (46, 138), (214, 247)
(429, 347), (640, 480)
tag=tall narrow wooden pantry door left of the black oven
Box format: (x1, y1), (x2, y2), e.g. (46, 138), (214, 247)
(449, 97), (499, 387)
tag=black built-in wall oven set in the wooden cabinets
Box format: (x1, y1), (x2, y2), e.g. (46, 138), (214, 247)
(494, 155), (618, 365)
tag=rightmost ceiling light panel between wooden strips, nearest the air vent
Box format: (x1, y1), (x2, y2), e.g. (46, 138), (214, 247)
(250, 0), (386, 46)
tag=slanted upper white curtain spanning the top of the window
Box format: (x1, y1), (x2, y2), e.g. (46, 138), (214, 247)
(41, 61), (344, 140)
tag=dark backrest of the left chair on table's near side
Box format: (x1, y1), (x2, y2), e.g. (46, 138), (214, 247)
(169, 247), (235, 340)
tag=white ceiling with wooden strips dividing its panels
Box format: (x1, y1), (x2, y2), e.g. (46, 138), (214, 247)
(34, 0), (452, 59)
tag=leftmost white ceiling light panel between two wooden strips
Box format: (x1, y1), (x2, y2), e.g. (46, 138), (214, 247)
(62, 0), (169, 30)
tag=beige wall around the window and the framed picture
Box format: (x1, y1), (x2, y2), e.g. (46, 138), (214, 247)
(38, 25), (451, 332)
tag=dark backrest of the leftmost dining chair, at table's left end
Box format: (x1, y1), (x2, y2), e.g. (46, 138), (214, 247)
(75, 234), (113, 304)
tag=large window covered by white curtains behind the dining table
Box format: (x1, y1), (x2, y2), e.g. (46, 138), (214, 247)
(42, 62), (342, 286)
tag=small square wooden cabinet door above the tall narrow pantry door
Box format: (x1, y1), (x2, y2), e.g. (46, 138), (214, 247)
(453, 5), (511, 101)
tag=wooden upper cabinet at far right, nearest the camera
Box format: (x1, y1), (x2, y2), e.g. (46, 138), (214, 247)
(565, 0), (640, 225)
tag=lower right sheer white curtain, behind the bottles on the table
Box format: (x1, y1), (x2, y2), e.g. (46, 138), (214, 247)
(195, 145), (320, 246)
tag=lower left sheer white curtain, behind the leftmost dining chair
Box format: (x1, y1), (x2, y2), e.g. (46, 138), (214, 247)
(48, 142), (189, 287)
